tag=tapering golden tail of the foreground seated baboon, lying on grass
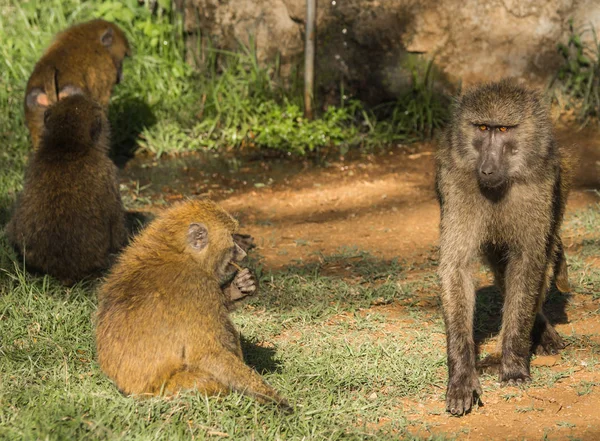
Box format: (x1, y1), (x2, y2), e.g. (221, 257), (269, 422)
(206, 351), (292, 411)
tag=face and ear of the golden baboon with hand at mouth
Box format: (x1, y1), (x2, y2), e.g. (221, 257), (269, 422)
(187, 222), (246, 279)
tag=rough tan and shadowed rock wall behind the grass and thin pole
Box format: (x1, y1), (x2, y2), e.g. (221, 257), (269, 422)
(185, 0), (600, 102)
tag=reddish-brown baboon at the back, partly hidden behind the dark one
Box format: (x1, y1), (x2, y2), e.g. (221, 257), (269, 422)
(25, 19), (131, 148)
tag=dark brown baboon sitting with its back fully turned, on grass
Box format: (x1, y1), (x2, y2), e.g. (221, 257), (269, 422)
(6, 94), (127, 284)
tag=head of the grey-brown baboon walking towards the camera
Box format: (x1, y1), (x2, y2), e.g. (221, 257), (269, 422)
(449, 80), (555, 190)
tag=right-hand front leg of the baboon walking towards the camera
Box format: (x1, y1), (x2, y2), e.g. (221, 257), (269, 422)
(500, 253), (548, 384)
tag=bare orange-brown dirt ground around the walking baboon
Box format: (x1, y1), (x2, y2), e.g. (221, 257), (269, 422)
(122, 131), (600, 440)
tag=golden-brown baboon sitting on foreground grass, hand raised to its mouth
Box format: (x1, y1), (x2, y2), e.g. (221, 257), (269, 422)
(96, 200), (289, 408)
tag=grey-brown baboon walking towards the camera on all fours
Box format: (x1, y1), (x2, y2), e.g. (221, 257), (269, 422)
(436, 80), (572, 415)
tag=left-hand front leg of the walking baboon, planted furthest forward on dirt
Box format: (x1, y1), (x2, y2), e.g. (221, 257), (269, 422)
(439, 239), (481, 415)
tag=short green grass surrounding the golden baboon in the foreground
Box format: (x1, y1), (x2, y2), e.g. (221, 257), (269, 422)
(0, 243), (452, 440)
